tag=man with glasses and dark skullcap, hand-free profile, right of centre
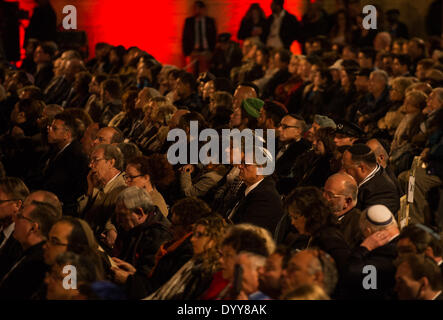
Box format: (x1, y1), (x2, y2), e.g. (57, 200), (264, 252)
(274, 114), (310, 193)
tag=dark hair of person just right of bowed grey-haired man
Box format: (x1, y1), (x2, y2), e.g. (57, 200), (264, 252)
(171, 197), (211, 229)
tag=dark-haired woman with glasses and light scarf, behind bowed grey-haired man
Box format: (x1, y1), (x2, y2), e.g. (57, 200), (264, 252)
(125, 154), (175, 217)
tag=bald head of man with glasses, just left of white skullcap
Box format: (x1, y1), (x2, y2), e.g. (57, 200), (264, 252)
(323, 172), (358, 216)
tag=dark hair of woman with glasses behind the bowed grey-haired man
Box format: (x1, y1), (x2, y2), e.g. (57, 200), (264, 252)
(127, 153), (175, 188)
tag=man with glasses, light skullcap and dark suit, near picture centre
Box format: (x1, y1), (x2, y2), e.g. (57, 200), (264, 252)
(228, 151), (283, 234)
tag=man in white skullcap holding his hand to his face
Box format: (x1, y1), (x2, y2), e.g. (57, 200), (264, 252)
(344, 205), (400, 300)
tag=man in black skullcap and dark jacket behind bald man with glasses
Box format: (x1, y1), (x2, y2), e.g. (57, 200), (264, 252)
(342, 144), (400, 215)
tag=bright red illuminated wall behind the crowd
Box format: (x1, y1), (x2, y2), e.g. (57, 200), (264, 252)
(13, 0), (303, 66)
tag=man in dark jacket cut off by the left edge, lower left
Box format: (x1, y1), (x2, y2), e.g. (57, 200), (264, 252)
(0, 177), (29, 278)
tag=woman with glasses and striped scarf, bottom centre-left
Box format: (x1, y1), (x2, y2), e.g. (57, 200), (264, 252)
(145, 215), (227, 300)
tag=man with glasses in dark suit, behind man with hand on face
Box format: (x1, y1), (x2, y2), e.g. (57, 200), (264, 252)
(39, 113), (89, 215)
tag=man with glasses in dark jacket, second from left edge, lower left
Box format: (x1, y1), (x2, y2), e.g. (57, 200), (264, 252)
(0, 202), (60, 300)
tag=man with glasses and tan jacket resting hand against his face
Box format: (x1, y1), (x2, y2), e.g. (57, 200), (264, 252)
(79, 144), (127, 249)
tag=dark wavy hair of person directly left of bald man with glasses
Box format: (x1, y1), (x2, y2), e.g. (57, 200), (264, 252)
(284, 187), (335, 235)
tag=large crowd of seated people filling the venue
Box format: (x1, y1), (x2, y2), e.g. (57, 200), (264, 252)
(0, 0), (443, 300)
